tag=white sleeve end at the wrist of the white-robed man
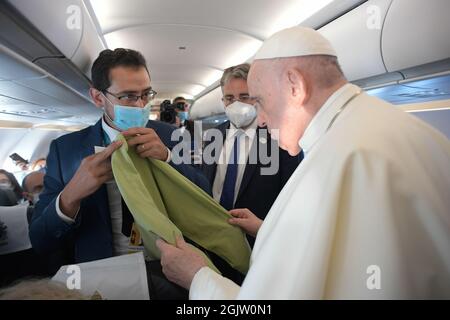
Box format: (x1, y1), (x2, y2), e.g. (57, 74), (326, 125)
(189, 267), (241, 300)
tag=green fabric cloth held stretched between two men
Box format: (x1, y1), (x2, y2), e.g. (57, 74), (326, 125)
(112, 135), (251, 274)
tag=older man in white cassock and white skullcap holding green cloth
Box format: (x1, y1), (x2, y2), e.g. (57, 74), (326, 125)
(157, 27), (450, 299)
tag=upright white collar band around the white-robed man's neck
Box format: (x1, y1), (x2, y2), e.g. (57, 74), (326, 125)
(298, 83), (360, 155)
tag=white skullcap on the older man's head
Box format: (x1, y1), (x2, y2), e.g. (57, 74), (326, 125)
(254, 26), (337, 60)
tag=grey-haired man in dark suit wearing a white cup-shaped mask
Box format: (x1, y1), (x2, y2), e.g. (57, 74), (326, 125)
(202, 64), (302, 241)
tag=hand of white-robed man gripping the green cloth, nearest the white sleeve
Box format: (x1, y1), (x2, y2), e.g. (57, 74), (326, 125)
(156, 237), (207, 290)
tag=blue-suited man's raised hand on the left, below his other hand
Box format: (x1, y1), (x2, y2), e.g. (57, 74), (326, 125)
(59, 141), (122, 219)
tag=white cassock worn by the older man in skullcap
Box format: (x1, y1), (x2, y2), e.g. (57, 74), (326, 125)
(190, 84), (450, 299)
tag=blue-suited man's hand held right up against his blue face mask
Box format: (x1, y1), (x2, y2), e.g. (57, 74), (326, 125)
(122, 128), (169, 161)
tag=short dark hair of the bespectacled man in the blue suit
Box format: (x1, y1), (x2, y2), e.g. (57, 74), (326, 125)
(91, 48), (148, 92)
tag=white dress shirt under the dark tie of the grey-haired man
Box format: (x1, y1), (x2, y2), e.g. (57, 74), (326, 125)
(213, 119), (258, 203)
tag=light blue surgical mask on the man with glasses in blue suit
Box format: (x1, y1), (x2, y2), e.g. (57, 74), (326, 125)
(105, 98), (151, 131)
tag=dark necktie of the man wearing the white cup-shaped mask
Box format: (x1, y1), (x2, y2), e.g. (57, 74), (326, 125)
(220, 133), (240, 210)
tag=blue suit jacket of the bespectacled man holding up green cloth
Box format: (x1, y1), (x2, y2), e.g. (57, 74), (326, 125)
(29, 120), (211, 262)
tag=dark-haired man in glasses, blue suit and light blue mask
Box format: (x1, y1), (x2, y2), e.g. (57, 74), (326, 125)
(30, 49), (210, 263)
